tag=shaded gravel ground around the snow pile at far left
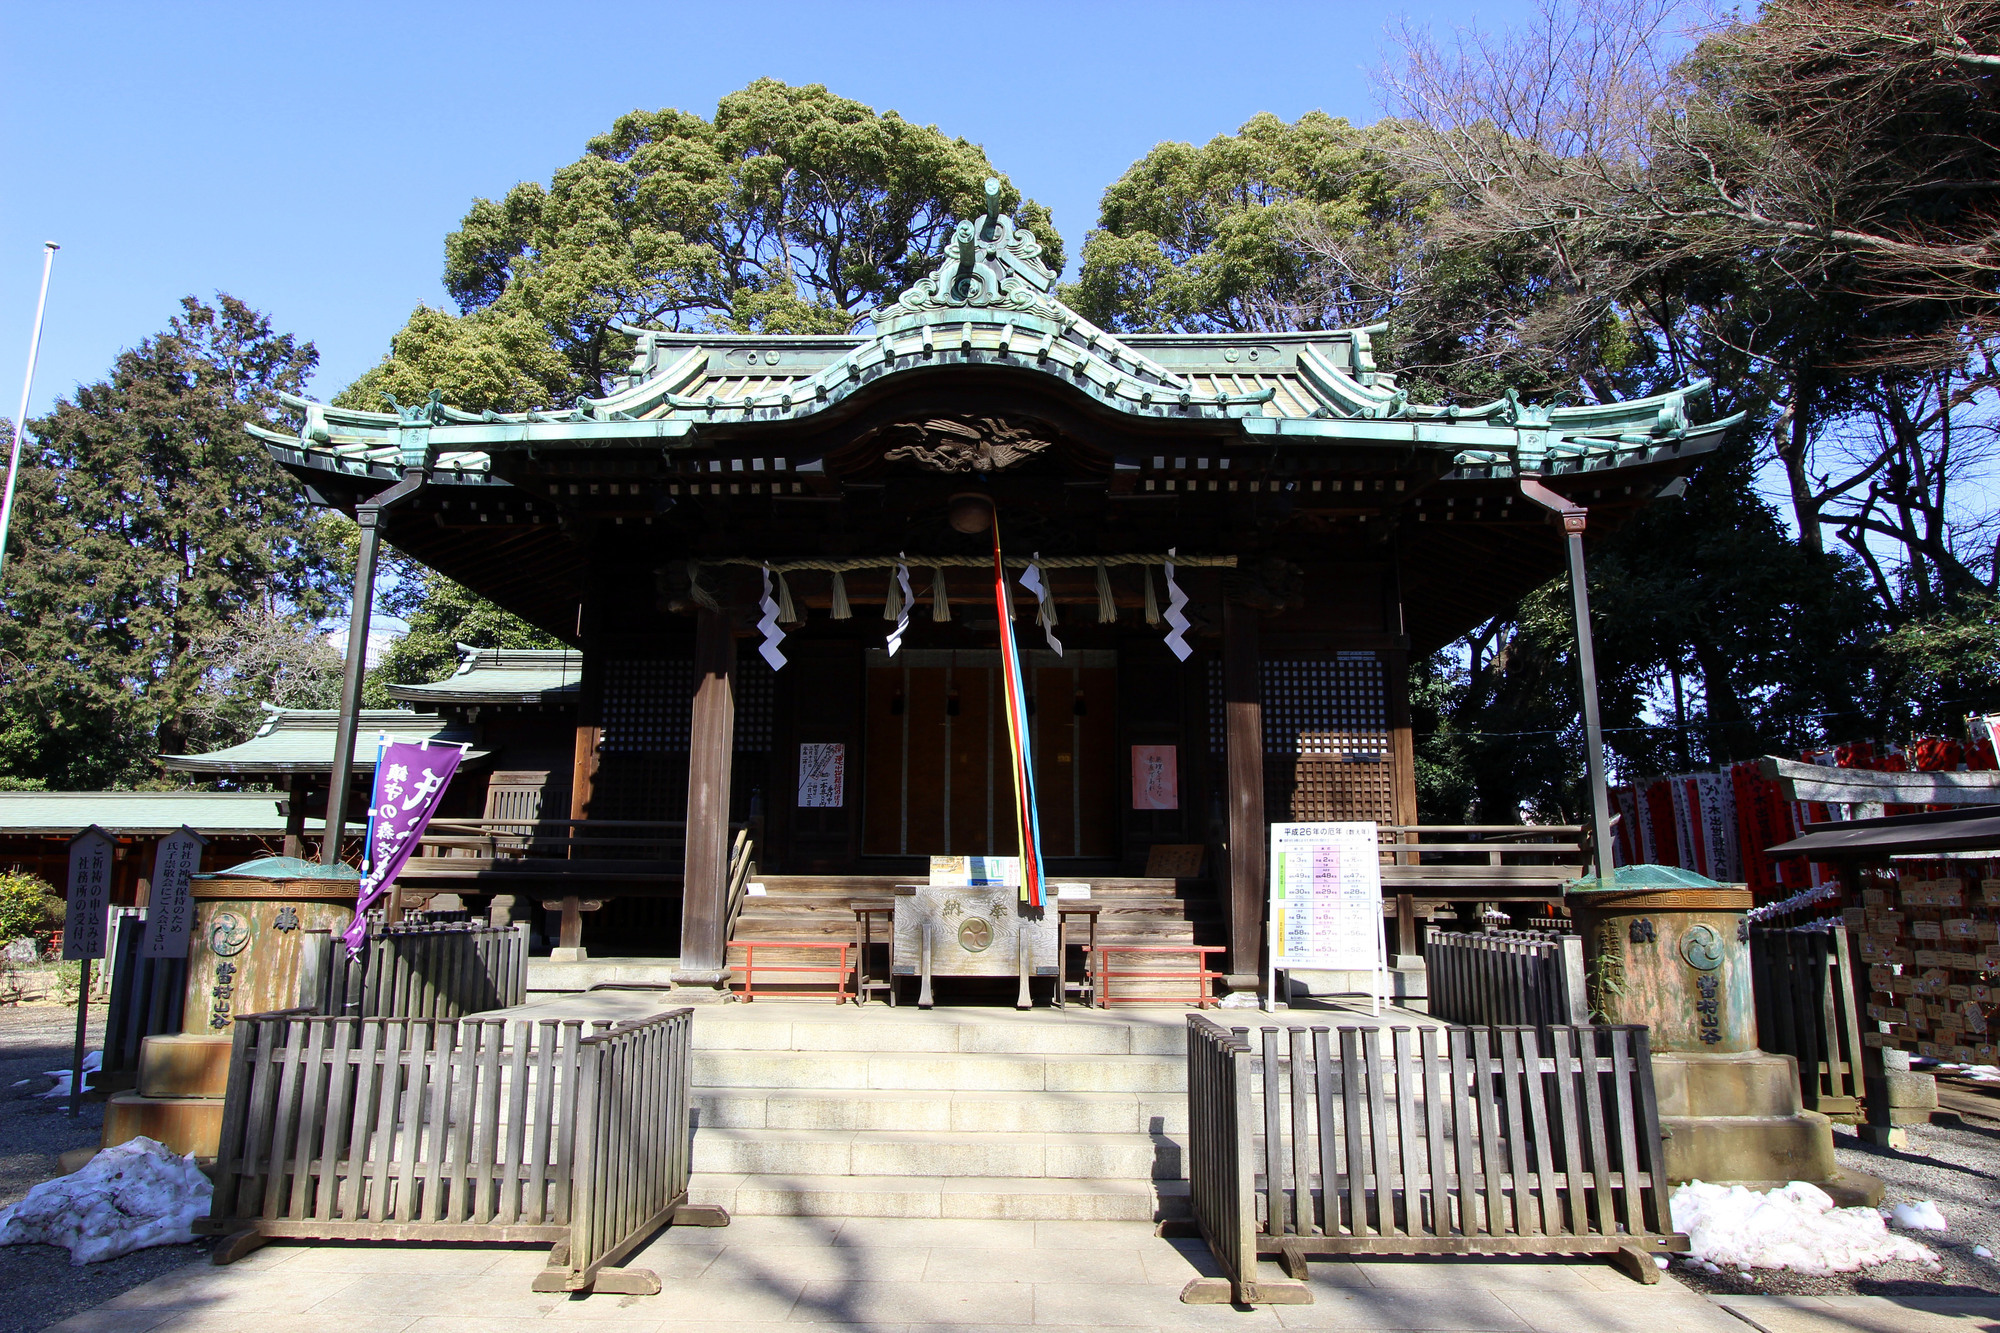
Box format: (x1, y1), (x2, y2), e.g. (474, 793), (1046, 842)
(0, 1001), (206, 1333)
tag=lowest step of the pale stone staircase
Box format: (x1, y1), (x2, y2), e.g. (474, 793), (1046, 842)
(688, 1173), (1188, 1221)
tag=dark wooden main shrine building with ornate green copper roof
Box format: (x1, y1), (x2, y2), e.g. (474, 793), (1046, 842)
(256, 190), (1736, 987)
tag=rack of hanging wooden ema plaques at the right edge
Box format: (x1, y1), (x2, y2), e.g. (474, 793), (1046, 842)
(1842, 863), (2000, 1065)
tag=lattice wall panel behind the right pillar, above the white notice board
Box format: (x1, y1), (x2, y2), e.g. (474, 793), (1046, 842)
(1208, 652), (1396, 823)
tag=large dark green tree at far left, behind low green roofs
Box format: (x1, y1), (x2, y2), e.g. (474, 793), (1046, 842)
(0, 296), (346, 789)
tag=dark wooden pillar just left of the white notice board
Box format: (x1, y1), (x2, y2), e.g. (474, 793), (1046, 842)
(1222, 602), (1268, 991)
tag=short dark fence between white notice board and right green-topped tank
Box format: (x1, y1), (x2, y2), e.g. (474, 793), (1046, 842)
(1424, 931), (1590, 1029)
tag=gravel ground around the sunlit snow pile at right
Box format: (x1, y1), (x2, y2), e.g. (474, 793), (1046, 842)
(1674, 1105), (2000, 1297)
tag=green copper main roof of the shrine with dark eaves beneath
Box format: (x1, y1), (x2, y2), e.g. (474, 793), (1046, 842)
(252, 184), (1740, 652)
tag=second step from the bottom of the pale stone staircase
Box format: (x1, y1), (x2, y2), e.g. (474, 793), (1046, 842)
(694, 1127), (1186, 1181)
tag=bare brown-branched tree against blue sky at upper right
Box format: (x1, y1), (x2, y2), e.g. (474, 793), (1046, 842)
(1384, 0), (2000, 600)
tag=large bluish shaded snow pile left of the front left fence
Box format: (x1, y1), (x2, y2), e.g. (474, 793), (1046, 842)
(0, 1137), (212, 1265)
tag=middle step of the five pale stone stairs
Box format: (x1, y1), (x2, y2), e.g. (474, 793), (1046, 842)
(694, 1087), (1188, 1137)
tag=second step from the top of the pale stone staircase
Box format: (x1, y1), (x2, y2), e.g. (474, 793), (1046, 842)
(694, 1049), (1188, 1093)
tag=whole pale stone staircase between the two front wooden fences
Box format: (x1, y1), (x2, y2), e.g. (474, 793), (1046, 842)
(690, 1001), (1188, 1221)
